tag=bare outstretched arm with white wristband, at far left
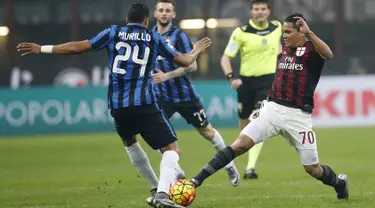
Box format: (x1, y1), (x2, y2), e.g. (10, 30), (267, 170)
(17, 40), (92, 56)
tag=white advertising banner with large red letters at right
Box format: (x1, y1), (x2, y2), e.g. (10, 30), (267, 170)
(313, 75), (375, 128)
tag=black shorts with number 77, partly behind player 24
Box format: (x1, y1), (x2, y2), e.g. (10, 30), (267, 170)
(159, 99), (209, 128)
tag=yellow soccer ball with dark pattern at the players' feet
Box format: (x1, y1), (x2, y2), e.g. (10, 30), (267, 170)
(169, 179), (195, 207)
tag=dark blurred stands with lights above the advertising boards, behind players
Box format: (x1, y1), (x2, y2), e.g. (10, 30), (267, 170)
(0, 0), (375, 88)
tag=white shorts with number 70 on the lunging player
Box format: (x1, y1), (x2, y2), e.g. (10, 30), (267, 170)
(241, 102), (319, 165)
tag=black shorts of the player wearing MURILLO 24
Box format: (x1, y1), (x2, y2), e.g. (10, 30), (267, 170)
(111, 104), (177, 150)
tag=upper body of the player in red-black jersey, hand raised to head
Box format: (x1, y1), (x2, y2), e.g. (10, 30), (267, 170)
(268, 15), (333, 113)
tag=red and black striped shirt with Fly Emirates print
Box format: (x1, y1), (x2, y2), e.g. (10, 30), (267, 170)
(268, 41), (325, 113)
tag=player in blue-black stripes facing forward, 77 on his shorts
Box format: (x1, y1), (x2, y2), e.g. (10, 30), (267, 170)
(153, 0), (239, 186)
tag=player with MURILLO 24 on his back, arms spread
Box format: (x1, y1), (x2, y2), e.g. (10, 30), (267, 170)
(17, 3), (211, 208)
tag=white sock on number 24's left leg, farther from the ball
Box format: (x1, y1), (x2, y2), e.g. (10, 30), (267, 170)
(125, 142), (158, 189)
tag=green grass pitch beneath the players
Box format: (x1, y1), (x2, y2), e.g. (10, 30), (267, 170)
(0, 127), (375, 208)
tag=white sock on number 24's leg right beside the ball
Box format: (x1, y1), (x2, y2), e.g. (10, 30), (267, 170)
(157, 151), (180, 194)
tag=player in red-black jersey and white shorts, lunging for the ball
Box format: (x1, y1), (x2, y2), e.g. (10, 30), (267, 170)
(192, 13), (349, 202)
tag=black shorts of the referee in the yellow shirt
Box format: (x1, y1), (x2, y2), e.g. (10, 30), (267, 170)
(237, 74), (275, 119)
